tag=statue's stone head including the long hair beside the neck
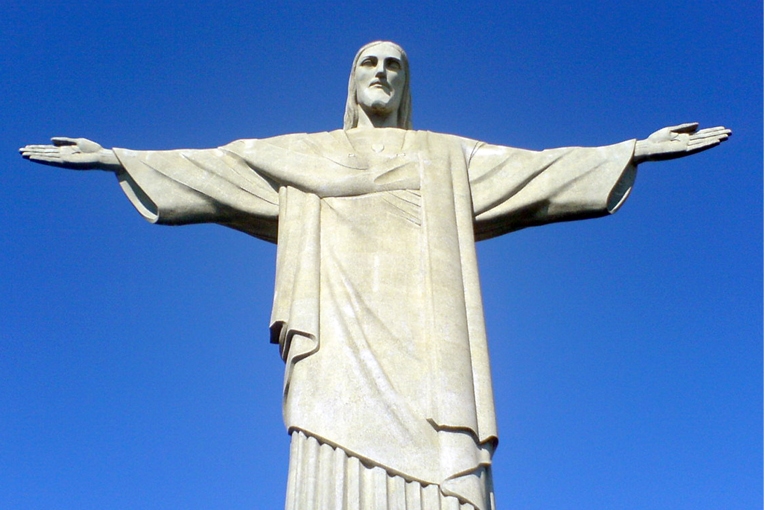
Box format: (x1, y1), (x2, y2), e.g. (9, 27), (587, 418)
(343, 41), (412, 129)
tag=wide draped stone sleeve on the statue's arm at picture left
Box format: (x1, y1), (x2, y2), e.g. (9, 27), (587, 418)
(114, 147), (279, 242)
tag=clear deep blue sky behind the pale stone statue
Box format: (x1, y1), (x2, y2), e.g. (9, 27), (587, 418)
(0, 0), (763, 510)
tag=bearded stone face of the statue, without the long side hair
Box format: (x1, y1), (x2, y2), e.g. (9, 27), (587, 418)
(355, 43), (406, 115)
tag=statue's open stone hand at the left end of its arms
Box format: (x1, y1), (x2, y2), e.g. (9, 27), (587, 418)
(19, 136), (124, 173)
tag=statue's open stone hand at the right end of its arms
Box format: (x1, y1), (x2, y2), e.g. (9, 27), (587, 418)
(633, 122), (731, 163)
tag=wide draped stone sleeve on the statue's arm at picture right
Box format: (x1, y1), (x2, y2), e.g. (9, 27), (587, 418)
(468, 140), (637, 240)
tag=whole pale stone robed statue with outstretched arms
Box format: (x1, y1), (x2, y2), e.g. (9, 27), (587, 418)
(21, 42), (730, 510)
